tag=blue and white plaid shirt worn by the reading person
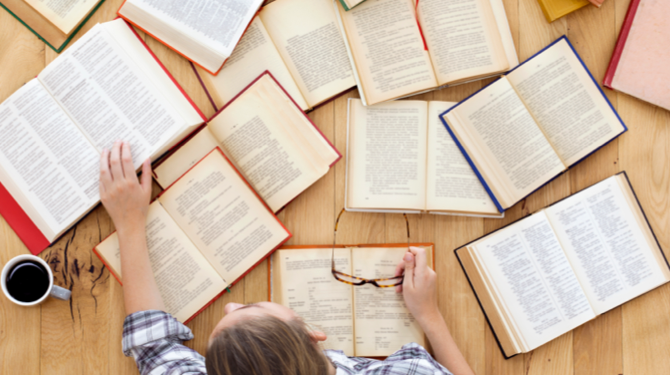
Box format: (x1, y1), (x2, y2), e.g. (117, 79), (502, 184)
(123, 310), (451, 375)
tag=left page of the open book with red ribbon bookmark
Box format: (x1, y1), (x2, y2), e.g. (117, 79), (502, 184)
(338, 0), (438, 105)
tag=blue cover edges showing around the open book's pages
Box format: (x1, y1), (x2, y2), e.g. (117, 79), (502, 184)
(440, 35), (628, 216)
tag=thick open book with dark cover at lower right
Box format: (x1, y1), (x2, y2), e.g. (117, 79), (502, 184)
(456, 173), (670, 357)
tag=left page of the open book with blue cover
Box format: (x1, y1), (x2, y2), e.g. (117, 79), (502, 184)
(446, 77), (565, 208)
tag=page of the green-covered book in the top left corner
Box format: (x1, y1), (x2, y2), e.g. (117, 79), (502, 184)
(23, 0), (100, 35)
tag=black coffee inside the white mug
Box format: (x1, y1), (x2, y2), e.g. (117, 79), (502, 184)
(6, 260), (49, 302)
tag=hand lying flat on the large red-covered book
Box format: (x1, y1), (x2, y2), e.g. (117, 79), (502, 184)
(100, 141), (151, 233)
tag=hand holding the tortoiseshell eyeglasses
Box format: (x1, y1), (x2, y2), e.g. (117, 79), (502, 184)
(396, 247), (441, 322)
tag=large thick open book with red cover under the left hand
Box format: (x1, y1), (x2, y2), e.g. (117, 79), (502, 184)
(0, 20), (204, 253)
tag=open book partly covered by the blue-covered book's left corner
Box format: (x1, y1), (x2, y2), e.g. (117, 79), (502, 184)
(344, 99), (502, 217)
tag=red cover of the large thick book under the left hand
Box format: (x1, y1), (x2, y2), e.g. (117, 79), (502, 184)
(0, 22), (207, 255)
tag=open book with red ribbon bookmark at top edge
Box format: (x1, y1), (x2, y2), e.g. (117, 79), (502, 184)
(334, 0), (518, 105)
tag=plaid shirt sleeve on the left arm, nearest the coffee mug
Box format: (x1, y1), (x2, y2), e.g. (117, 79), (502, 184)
(123, 310), (207, 375)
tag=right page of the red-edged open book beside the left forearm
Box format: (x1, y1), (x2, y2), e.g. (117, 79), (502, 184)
(158, 148), (290, 284)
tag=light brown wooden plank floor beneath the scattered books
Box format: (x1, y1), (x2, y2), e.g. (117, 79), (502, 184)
(0, 0), (670, 375)
